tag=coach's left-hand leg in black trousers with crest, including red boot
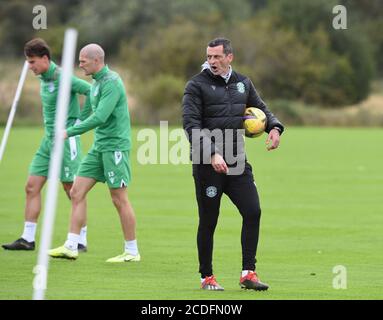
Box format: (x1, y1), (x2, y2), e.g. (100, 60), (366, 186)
(193, 164), (225, 290)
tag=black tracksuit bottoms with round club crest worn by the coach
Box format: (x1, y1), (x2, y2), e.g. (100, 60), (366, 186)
(193, 162), (261, 278)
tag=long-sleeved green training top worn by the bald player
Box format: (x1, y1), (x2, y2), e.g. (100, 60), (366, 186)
(67, 66), (131, 152)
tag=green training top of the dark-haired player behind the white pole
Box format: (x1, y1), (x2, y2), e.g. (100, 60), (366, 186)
(39, 61), (91, 138)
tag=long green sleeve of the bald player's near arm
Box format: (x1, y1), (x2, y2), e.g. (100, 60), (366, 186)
(67, 81), (120, 137)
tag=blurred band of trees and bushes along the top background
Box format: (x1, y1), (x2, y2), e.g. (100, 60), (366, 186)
(0, 0), (383, 122)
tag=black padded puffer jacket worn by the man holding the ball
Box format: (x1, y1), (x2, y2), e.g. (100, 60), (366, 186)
(182, 69), (284, 160)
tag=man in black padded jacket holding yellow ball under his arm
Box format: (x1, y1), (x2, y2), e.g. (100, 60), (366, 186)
(182, 38), (284, 290)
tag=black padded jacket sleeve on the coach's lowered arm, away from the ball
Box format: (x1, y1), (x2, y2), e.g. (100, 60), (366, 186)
(182, 80), (216, 163)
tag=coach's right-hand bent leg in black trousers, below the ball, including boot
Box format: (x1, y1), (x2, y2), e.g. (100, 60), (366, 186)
(224, 163), (268, 290)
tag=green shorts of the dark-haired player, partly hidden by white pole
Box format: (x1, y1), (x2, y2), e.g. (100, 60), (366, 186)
(29, 136), (81, 182)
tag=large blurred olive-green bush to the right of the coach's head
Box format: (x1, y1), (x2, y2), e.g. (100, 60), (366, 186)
(231, 7), (373, 107)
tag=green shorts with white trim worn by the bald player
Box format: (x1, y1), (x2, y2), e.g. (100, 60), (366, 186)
(78, 148), (131, 189)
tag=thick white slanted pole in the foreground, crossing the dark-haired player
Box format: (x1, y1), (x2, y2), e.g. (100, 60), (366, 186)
(33, 29), (77, 300)
